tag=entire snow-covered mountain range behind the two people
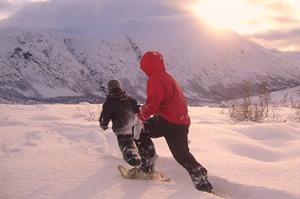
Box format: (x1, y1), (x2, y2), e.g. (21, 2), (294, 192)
(0, 5), (300, 104)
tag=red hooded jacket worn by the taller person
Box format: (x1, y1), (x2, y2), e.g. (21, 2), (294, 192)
(137, 51), (190, 125)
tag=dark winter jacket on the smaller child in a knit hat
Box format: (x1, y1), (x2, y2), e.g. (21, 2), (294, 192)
(99, 88), (139, 135)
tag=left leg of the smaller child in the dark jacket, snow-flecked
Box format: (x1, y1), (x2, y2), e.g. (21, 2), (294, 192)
(117, 135), (141, 166)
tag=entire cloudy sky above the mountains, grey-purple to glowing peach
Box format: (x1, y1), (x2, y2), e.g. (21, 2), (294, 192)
(0, 0), (300, 51)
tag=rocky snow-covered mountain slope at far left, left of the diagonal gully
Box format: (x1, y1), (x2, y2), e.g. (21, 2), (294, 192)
(0, 29), (99, 101)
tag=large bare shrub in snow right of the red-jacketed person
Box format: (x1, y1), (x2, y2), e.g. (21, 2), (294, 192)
(228, 81), (271, 122)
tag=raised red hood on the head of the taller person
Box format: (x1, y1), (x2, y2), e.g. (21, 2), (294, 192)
(140, 50), (166, 76)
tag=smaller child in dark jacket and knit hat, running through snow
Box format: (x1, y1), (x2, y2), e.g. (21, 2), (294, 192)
(99, 79), (155, 166)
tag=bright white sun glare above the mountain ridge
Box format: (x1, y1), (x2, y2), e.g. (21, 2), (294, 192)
(190, 0), (260, 32)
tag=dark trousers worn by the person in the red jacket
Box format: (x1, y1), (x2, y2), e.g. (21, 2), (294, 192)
(142, 116), (203, 175)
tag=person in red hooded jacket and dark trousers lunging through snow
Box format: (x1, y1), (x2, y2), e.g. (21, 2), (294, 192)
(137, 50), (213, 192)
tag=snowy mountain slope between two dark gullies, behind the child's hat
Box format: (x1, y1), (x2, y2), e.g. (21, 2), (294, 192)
(61, 33), (146, 99)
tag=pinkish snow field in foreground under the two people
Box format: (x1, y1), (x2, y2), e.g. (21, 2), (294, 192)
(0, 103), (300, 199)
